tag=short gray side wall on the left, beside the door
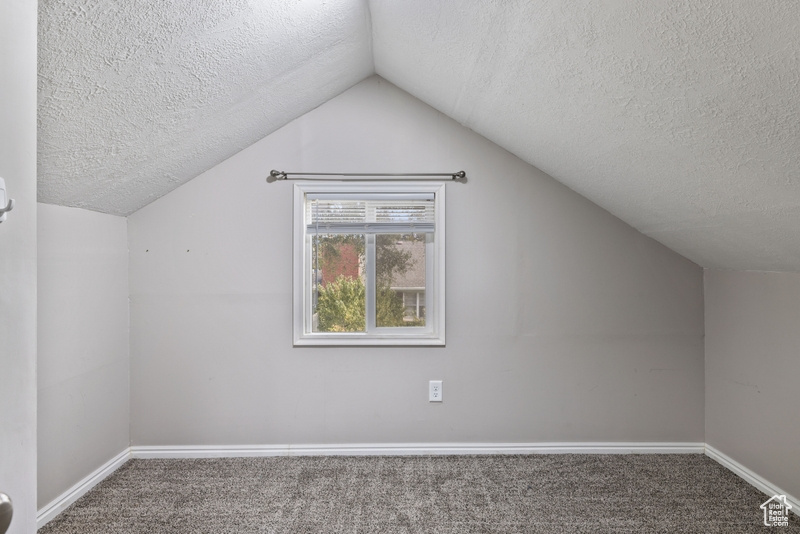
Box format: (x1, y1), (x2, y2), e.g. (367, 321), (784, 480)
(38, 204), (130, 508)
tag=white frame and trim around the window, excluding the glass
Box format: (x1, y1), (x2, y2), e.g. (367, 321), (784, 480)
(293, 182), (445, 346)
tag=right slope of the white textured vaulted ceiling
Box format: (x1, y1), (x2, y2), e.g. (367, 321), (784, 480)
(370, 0), (800, 271)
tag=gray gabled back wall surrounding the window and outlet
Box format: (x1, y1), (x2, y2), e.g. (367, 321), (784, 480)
(128, 77), (704, 445)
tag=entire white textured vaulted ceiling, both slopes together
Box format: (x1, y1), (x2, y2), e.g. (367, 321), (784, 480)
(39, 0), (800, 271)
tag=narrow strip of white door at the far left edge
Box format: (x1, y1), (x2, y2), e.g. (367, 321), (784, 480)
(0, 0), (36, 534)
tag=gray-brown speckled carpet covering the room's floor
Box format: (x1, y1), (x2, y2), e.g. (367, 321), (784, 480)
(39, 454), (800, 534)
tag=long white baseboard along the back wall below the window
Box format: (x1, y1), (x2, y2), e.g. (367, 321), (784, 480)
(131, 443), (705, 458)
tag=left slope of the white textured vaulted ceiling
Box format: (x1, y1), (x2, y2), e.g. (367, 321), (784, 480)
(38, 0), (374, 215)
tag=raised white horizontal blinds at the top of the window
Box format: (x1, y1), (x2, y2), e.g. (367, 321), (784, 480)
(306, 193), (435, 234)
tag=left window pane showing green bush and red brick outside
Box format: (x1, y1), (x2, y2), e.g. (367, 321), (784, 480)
(309, 234), (366, 332)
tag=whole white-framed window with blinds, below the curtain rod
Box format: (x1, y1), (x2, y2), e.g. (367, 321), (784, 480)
(294, 183), (445, 345)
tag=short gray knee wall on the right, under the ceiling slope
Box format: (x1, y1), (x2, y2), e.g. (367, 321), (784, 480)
(705, 271), (800, 498)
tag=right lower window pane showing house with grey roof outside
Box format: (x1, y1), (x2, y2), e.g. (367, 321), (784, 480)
(375, 234), (426, 327)
